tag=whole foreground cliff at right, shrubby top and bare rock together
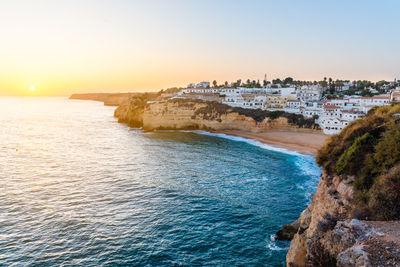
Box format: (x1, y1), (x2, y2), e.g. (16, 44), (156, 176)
(279, 105), (400, 266)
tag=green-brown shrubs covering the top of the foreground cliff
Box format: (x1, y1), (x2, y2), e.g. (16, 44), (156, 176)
(317, 105), (400, 220)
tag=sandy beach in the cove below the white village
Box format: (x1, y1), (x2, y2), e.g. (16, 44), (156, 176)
(221, 130), (328, 155)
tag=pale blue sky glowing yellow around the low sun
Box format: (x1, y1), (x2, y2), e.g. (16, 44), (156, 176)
(0, 0), (400, 96)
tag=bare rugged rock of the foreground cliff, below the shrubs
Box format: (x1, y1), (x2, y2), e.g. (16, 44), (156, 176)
(286, 172), (400, 267)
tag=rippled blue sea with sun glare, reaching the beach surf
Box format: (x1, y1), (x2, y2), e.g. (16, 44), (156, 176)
(0, 98), (320, 266)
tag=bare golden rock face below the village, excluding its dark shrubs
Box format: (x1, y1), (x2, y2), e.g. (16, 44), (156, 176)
(114, 100), (318, 132)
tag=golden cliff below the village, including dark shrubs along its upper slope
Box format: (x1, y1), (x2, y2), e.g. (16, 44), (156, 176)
(114, 98), (318, 132)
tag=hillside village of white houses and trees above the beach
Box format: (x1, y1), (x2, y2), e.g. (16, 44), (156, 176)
(156, 77), (400, 135)
